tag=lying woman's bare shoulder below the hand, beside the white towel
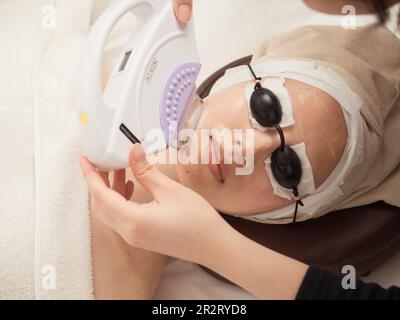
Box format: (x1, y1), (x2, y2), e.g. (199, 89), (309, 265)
(92, 212), (165, 300)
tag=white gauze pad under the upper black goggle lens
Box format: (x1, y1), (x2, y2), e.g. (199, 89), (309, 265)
(246, 78), (296, 131)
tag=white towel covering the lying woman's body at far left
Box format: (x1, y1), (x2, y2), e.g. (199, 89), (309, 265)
(0, 0), (99, 299)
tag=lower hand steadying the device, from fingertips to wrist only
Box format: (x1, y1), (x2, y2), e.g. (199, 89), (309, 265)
(81, 145), (227, 263)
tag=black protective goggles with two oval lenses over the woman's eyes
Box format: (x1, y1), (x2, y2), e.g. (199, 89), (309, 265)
(198, 56), (304, 223)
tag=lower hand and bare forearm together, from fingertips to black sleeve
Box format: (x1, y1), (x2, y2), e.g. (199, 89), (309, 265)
(81, 145), (307, 299)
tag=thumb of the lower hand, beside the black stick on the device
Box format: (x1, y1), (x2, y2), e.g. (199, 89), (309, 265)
(129, 144), (179, 201)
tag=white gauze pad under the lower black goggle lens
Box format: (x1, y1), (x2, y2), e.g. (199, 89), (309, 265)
(265, 143), (315, 200)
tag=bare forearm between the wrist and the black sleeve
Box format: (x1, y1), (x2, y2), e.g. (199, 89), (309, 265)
(199, 224), (308, 300)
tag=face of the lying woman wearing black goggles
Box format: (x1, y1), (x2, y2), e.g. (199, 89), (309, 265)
(177, 80), (347, 215)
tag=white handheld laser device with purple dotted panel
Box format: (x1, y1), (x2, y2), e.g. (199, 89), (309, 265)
(77, 0), (201, 171)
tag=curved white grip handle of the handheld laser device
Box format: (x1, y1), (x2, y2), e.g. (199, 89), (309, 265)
(80, 0), (165, 117)
